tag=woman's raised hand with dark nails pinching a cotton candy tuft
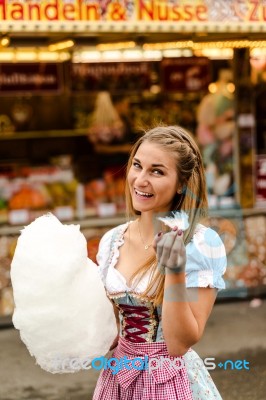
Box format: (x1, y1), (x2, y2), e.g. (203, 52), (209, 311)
(153, 227), (186, 274)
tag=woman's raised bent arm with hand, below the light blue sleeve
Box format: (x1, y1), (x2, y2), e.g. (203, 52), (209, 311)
(156, 231), (216, 357)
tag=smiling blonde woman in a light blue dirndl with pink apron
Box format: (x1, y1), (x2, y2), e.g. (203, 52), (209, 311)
(93, 126), (226, 400)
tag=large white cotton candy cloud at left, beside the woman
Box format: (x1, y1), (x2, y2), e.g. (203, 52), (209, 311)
(11, 214), (117, 373)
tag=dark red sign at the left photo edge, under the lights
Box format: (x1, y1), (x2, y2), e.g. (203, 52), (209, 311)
(0, 63), (62, 94)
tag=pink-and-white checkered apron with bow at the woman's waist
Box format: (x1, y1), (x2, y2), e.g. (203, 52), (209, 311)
(93, 337), (193, 400)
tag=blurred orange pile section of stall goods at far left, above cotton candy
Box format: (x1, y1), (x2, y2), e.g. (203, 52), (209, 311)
(0, 165), (78, 224)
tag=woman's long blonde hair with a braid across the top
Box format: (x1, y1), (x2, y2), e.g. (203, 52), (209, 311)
(125, 126), (208, 305)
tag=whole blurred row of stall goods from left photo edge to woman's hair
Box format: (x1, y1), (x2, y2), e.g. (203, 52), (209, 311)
(0, 165), (125, 225)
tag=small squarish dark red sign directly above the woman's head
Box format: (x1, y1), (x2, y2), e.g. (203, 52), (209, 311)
(161, 57), (211, 92)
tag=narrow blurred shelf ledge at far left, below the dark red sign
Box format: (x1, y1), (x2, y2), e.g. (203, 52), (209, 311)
(0, 128), (88, 140)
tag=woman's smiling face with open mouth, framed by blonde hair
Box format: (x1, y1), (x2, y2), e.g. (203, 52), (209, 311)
(127, 141), (179, 213)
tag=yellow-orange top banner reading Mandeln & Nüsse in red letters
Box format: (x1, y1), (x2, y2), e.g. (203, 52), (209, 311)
(0, 0), (266, 25)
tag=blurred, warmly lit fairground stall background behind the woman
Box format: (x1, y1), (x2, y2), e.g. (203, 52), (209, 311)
(0, 0), (266, 400)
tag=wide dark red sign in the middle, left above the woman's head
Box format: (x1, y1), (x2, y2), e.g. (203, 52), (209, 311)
(71, 61), (153, 91)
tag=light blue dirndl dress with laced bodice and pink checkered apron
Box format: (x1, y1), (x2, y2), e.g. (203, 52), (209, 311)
(93, 224), (226, 400)
